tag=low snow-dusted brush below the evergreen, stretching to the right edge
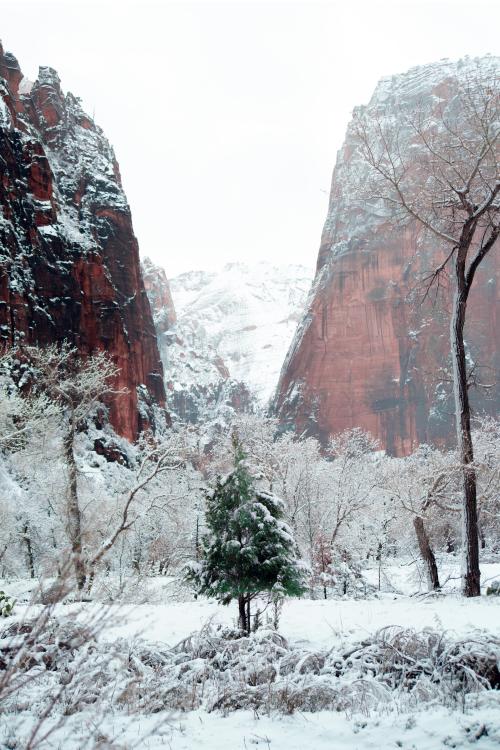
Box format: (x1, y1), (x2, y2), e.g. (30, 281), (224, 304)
(118, 627), (500, 714)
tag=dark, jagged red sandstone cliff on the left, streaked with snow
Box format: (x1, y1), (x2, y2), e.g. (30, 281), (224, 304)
(0, 46), (165, 439)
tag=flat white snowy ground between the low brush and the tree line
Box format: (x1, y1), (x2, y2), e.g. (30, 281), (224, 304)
(7, 556), (500, 648)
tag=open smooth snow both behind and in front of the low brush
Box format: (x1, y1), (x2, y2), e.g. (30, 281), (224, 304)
(0, 565), (500, 750)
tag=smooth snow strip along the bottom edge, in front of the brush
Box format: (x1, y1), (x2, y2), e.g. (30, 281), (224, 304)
(109, 704), (500, 750)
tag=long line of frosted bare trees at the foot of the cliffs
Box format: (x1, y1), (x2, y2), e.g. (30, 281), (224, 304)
(0, 345), (500, 612)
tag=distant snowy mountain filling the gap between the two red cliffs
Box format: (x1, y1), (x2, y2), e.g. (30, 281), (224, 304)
(144, 261), (312, 423)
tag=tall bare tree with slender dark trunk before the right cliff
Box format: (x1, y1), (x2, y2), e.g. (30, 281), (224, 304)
(354, 60), (500, 596)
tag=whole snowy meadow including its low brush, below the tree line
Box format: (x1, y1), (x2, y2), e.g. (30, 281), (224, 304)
(1, 564), (500, 750)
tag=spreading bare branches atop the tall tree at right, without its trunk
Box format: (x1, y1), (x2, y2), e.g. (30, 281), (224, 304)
(354, 64), (500, 262)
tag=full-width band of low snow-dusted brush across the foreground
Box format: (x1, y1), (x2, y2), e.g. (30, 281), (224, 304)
(0, 608), (500, 747)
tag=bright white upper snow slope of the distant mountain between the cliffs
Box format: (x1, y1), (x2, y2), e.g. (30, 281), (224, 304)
(167, 262), (312, 404)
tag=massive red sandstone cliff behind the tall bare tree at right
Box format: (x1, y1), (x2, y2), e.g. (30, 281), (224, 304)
(274, 58), (500, 455)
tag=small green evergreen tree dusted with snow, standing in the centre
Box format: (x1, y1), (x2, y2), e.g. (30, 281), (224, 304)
(187, 445), (306, 633)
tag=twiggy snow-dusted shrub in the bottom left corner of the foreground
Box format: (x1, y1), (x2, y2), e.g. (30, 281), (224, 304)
(0, 605), (130, 750)
